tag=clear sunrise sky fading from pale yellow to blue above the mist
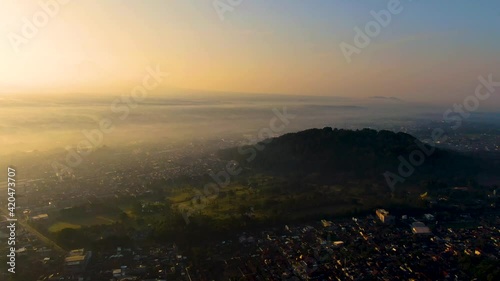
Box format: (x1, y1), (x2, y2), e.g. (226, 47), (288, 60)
(0, 0), (500, 108)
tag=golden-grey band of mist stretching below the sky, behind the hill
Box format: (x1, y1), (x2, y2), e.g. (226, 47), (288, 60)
(0, 93), (500, 155)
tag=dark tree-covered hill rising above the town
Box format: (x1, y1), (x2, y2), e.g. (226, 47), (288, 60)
(220, 127), (479, 184)
